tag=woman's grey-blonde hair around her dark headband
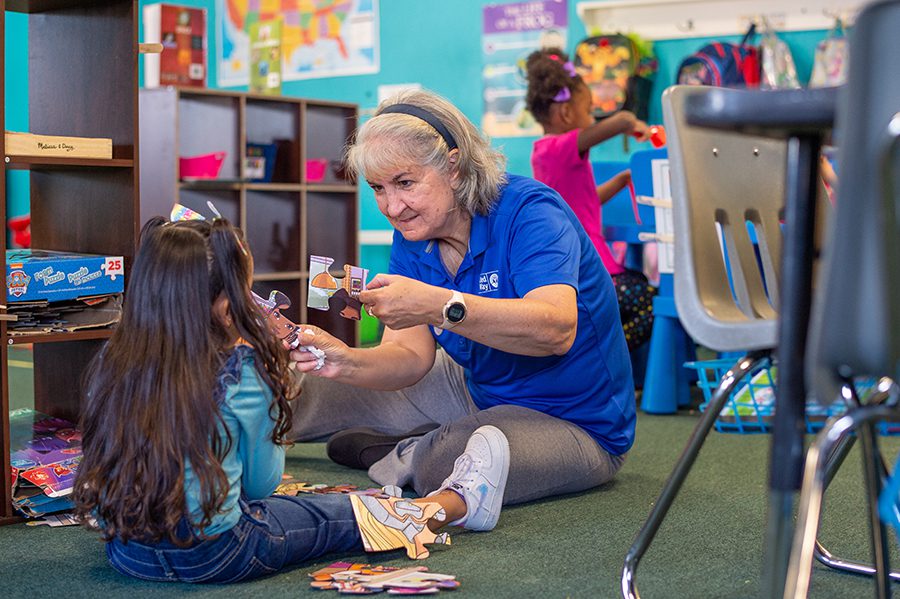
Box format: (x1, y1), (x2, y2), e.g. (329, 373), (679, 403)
(344, 90), (506, 215)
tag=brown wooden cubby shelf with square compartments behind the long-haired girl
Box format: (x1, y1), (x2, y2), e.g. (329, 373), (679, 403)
(140, 87), (359, 345)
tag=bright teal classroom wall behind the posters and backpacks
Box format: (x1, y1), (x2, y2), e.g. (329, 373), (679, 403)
(134, 0), (824, 239)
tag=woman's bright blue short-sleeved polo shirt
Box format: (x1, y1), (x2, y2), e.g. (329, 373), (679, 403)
(390, 175), (635, 455)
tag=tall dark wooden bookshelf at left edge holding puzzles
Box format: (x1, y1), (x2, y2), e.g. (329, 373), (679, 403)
(0, 0), (140, 523)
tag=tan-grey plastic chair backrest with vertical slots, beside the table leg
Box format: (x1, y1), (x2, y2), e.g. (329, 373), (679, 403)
(662, 86), (787, 351)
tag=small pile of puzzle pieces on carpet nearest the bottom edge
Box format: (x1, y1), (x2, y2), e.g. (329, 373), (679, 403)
(309, 562), (459, 595)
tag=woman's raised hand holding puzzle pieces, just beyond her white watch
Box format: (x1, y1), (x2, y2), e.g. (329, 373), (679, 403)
(359, 274), (450, 331)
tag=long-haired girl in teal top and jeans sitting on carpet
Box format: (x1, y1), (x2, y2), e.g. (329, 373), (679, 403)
(74, 218), (509, 582)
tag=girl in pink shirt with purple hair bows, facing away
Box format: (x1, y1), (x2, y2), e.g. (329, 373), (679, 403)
(525, 48), (656, 350)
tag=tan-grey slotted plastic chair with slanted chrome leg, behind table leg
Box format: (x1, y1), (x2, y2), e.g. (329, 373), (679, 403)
(621, 86), (834, 597)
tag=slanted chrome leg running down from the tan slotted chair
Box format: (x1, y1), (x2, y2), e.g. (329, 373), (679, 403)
(621, 351), (769, 599)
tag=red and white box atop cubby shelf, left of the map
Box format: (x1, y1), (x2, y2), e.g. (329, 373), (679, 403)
(143, 4), (206, 88)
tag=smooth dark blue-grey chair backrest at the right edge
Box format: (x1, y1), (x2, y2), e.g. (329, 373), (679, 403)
(810, 0), (900, 399)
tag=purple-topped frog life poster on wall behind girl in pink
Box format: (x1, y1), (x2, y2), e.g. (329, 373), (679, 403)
(481, 0), (569, 137)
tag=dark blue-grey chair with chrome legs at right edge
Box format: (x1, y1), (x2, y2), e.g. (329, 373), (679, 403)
(784, 0), (900, 598)
